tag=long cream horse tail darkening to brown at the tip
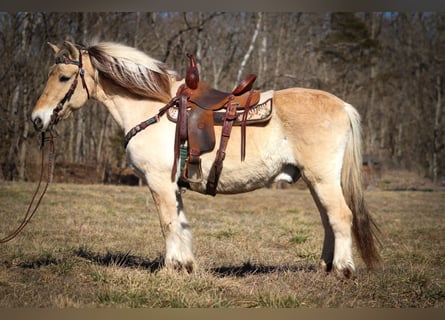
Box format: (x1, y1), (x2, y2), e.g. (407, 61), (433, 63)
(341, 103), (380, 269)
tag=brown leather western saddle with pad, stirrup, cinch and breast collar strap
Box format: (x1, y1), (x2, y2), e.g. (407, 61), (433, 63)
(124, 54), (272, 196)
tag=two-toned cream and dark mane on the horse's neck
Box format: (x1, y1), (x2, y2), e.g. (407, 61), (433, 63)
(87, 42), (174, 102)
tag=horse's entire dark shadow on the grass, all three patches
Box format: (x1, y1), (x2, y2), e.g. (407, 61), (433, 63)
(19, 247), (317, 278)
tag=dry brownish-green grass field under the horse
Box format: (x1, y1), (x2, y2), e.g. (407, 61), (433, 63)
(0, 182), (445, 308)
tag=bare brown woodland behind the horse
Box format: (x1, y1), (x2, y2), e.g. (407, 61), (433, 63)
(0, 12), (445, 183)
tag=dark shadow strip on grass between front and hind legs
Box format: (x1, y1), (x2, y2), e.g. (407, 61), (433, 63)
(210, 262), (317, 277)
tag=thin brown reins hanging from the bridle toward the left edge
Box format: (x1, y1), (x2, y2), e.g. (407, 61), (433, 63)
(0, 131), (54, 243)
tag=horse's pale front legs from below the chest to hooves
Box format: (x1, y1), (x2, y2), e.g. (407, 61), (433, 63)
(151, 188), (195, 273)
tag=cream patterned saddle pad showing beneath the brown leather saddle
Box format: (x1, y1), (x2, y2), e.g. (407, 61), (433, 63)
(167, 90), (274, 125)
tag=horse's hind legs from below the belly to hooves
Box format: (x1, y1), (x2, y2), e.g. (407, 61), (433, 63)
(309, 178), (355, 278)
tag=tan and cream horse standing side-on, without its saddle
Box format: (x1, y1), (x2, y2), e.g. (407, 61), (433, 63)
(31, 41), (380, 278)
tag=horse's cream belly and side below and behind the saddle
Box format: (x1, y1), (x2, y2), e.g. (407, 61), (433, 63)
(187, 118), (299, 194)
